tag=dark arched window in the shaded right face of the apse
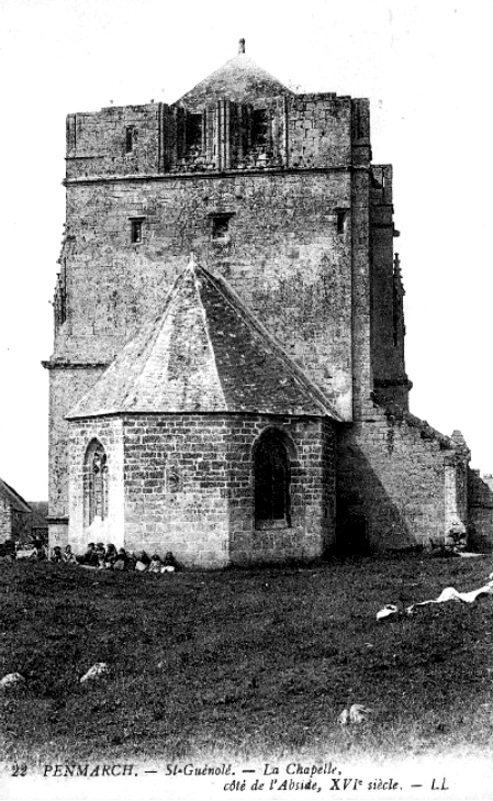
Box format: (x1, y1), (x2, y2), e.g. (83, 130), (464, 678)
(255, 429), (291, 526)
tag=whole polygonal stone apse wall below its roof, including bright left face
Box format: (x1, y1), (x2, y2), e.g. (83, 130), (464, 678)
(69, 413), (335, 567)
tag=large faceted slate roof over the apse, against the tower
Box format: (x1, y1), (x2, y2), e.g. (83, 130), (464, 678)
(67, 257), (338, 419)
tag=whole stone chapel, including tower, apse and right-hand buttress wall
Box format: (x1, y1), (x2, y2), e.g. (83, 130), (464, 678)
(45, 40), (491, 567)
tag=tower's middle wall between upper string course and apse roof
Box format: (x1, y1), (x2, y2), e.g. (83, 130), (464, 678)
(55, 172), (352, 418)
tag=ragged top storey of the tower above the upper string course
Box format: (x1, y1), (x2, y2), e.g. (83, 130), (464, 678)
(63, 92), (370, 179)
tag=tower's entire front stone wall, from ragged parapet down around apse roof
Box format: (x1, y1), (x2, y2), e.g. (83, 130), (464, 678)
(50, 84), (372, 548)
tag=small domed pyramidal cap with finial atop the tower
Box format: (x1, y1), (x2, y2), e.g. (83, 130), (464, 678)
(178, 39), (292, 105)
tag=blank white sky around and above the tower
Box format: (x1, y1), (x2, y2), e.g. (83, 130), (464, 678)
(0, 0), (493, 500)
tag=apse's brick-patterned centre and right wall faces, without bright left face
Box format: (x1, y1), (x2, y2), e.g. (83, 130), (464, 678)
(118, 415), (334, 567)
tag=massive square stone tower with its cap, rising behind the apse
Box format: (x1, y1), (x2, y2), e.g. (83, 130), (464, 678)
(46, 40), (466, 555)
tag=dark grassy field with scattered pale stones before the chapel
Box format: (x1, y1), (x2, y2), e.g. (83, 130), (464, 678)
(0, 556), (493, 762)
